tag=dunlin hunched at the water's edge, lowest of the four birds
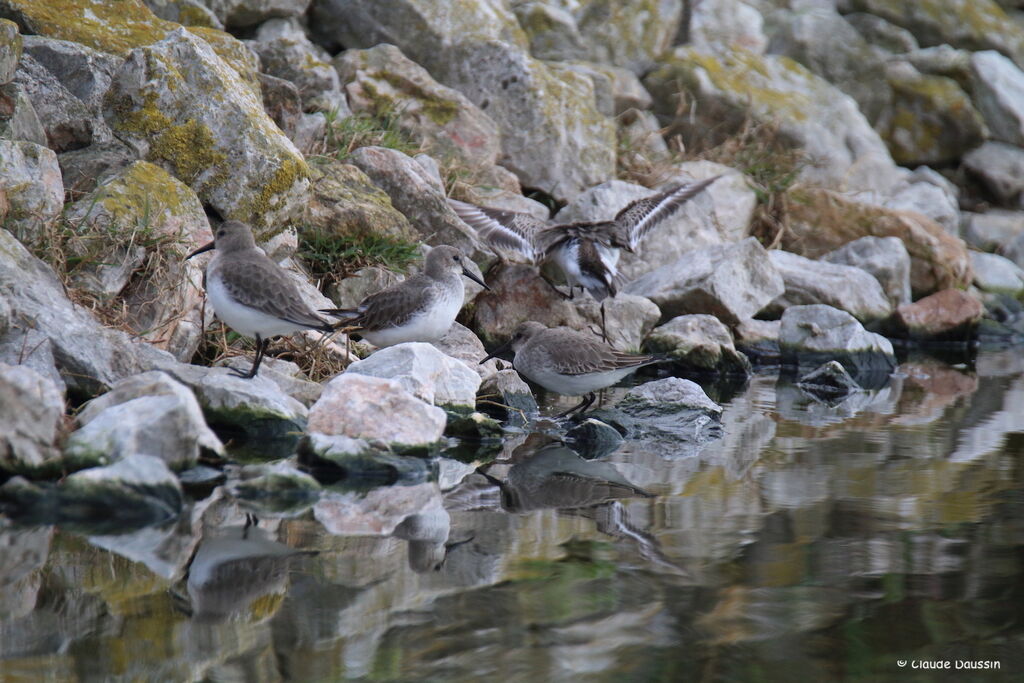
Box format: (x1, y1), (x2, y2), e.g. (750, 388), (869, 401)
(480, 322), (660, 418)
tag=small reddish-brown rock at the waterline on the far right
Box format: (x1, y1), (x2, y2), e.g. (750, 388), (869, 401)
(890, 290), (985, 342)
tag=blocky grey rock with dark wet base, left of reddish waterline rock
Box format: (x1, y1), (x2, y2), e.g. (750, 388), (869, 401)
(778, 304), (896, 376)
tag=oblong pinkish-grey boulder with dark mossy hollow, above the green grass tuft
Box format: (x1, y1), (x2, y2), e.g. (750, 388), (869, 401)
(334, 45), (501, 168)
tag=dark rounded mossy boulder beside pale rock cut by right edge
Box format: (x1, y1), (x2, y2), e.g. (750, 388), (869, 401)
(876, 62), (987, 166)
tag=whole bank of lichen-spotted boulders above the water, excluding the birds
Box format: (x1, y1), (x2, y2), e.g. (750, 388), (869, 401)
(0, 0), (1024, 528)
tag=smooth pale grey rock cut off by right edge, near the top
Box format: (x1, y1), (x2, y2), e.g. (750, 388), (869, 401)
(971, 50), (1024, 145)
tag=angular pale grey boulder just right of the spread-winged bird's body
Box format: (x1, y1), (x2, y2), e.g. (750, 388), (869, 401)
(624, 238), (785, 327)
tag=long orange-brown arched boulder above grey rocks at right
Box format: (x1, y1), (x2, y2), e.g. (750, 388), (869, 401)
(781, 187), (971, 296)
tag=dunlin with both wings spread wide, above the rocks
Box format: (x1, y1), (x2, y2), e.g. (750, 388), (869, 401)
(449, 176), (720, 301)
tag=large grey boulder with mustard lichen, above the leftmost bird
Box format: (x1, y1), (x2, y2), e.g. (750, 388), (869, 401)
(106, 29), (309, 227)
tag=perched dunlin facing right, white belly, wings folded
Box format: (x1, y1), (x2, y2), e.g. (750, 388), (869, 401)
(322, 247), (488, 346)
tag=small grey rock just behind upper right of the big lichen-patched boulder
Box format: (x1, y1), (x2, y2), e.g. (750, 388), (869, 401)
(249, 18), (341, 102)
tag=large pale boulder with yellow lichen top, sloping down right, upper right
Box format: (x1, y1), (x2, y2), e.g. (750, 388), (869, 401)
(644, 46), (903, 194)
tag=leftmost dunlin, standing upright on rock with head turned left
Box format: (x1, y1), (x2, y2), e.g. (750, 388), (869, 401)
(186, 220), (333, 379)
